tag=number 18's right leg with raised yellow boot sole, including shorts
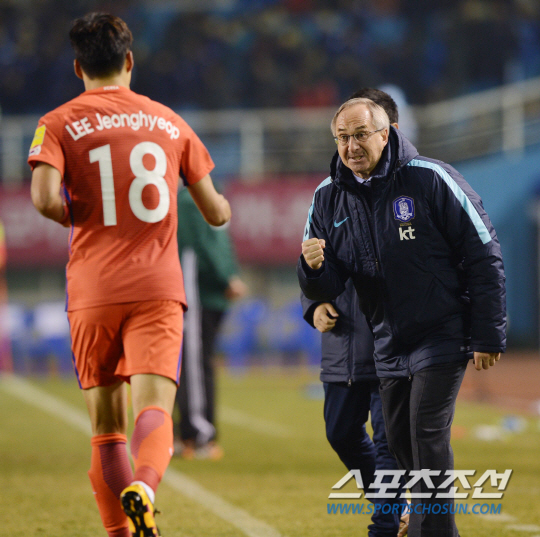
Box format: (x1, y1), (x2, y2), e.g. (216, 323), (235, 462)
(116, 300), (183, 537)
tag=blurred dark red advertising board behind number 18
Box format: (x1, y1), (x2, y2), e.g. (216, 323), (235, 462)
(0, 176), (321, 268)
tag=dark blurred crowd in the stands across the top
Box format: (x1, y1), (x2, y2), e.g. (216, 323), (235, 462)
(0, 0), (540, 114)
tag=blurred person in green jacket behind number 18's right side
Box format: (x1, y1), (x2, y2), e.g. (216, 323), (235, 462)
(174, 185), (247, 460)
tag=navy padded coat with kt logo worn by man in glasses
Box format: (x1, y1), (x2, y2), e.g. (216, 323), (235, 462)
(297, 127), (506, 377)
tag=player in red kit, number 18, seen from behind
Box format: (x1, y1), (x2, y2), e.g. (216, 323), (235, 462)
(28, 13), (230, 537)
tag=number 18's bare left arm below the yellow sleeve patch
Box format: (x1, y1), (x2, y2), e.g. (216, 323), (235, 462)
(30, 162), (69, 227)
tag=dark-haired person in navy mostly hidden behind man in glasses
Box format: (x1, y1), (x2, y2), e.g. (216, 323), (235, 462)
(301, 88), (409, 537)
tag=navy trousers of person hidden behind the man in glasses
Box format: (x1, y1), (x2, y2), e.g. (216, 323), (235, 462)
(324, 380), (405, 537)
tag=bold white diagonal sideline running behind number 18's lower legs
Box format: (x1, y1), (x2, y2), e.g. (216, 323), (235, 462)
(0, 375), (282, 537)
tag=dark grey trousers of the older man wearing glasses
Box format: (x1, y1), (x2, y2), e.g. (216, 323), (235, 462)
(380, 359), (467, 537)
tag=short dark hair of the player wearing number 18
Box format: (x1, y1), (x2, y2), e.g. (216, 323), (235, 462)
(69, 13), (133, 78)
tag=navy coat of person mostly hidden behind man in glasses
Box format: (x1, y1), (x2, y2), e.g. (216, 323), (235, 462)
(300, 280), (377, 384)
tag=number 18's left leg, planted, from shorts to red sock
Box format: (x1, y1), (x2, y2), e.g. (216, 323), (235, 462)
(68, 305), (133, 537)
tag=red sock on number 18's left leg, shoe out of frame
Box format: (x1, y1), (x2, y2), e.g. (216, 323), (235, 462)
(88, 433), (133, 537)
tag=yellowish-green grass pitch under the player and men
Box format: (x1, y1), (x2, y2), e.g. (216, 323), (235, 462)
(0, 368), (540, 537)
